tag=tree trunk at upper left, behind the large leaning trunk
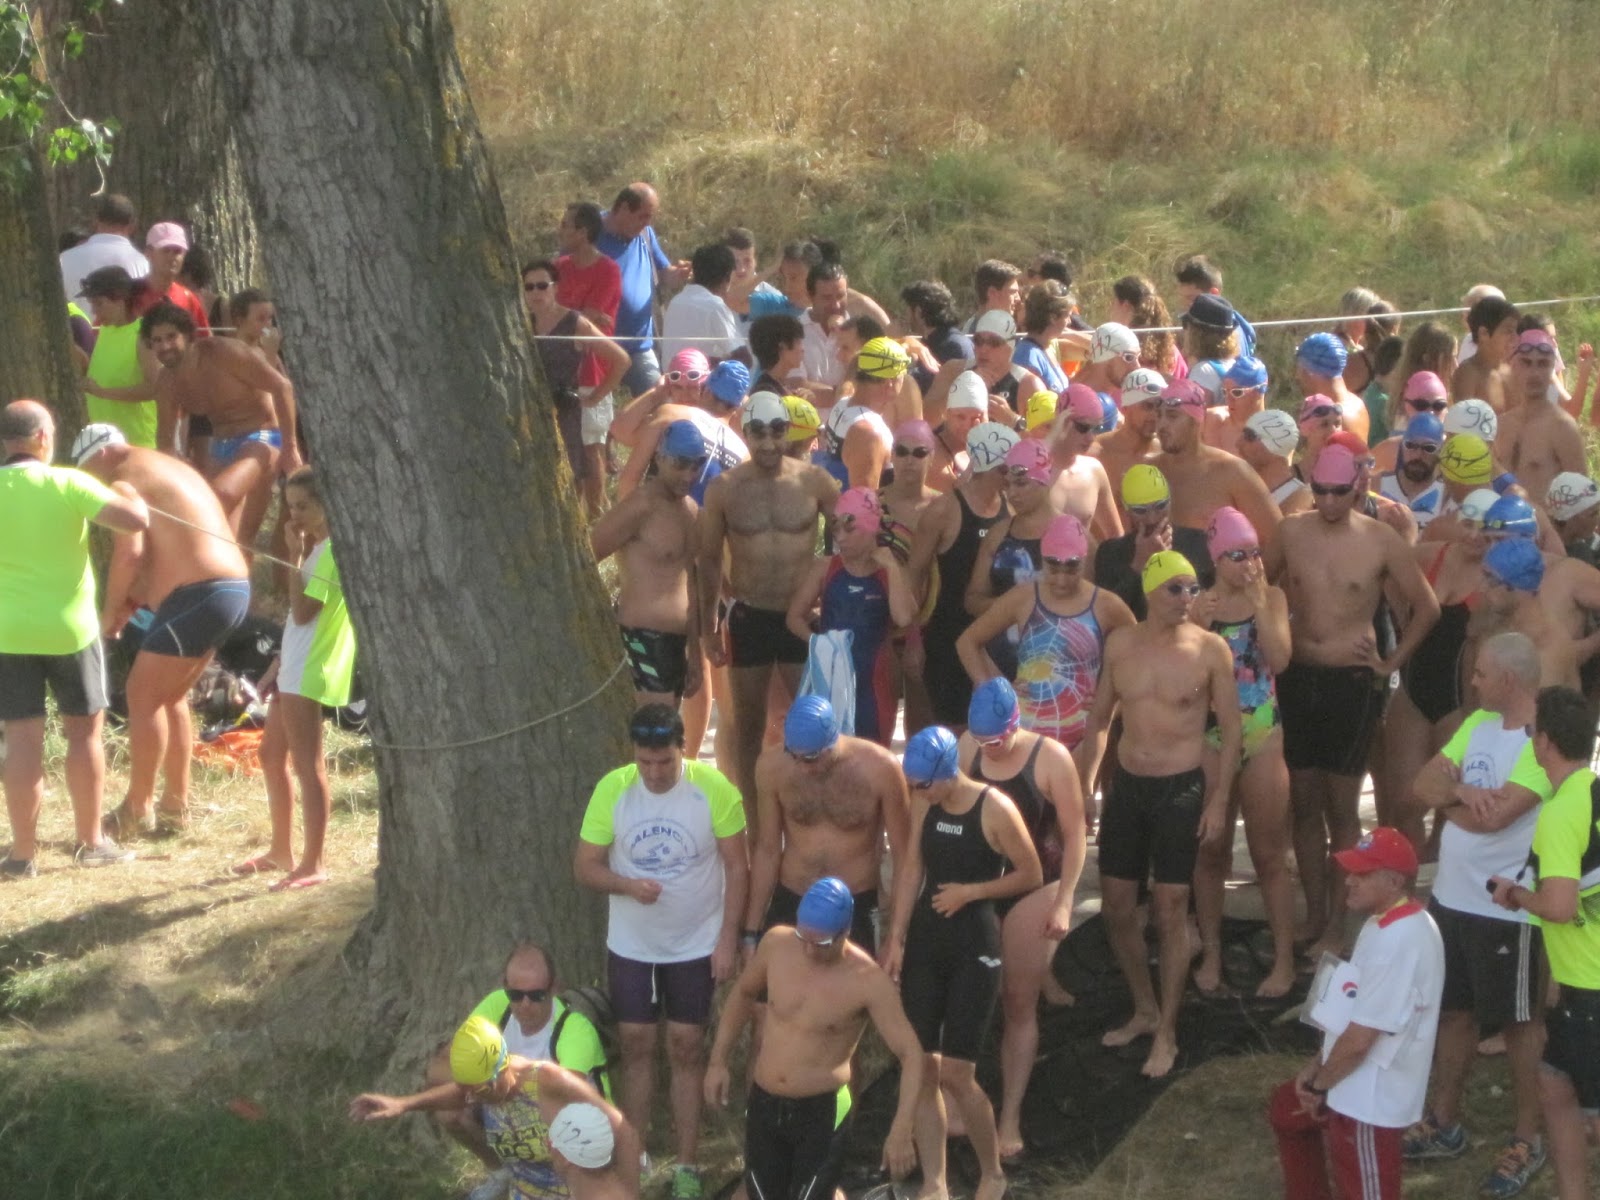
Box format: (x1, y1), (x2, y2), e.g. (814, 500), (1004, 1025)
(42, 0), (266, 296)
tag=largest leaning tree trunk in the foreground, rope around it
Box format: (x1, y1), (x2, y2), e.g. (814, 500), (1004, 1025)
(210, 0), (630, 1066)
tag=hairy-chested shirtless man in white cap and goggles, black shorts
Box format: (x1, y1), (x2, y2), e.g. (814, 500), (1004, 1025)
(699, 392), (838, 832)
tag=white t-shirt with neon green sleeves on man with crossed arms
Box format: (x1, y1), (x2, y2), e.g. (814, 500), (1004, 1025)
(1434, 709), (1550, 922)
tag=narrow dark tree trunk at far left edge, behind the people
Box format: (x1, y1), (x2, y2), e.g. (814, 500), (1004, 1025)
(0, 146), (83, 445)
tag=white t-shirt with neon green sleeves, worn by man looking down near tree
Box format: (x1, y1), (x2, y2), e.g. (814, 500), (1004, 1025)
(578, 760), (744, 963)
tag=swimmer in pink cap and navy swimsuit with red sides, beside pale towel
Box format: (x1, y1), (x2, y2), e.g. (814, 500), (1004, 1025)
(786, 488), (917, 746)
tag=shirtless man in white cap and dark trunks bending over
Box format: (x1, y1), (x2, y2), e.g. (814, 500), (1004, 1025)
(72, 424), (250, 838)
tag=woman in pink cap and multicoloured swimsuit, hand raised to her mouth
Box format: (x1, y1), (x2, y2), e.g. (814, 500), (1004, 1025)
(1190, 507), (1294, 998)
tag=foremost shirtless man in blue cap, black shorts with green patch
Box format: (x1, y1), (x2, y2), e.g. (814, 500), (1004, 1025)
(706, 878), (923, 1200)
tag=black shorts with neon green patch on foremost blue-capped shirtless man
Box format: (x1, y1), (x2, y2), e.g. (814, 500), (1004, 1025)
(744, 1083), (851, 1200)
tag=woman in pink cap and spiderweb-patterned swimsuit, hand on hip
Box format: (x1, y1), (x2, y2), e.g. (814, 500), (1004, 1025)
(955, 514), (1133, 750)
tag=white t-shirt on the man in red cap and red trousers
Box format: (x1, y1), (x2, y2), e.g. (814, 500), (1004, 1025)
(1322, 901), (1445, 1130)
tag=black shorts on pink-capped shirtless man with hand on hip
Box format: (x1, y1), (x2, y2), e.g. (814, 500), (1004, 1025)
(1278, 662), (1389, 776)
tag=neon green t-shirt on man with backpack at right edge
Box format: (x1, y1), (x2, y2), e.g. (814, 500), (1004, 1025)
(1533, 766), (1600, 990)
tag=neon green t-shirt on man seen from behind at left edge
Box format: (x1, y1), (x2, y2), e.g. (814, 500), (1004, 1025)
(0, 459), (117, 654)
